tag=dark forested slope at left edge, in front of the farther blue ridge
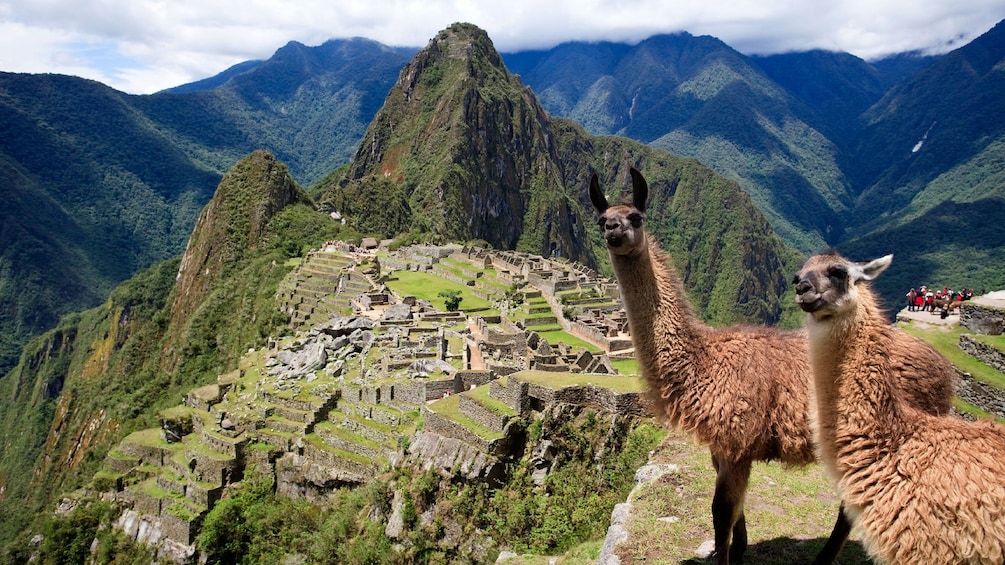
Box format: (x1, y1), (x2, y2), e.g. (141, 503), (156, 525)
(0, 73), (219, 375)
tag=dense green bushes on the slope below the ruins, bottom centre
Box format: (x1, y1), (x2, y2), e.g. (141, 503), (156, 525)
(185, 412), (662, 563)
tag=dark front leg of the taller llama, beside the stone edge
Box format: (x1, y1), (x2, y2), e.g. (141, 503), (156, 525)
(712, 454), (751, 565)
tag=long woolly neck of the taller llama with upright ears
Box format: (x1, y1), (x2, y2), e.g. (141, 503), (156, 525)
(611, 230), (702, 381)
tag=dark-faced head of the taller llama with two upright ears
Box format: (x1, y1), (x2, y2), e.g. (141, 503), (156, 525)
(590, 167), (649, 255)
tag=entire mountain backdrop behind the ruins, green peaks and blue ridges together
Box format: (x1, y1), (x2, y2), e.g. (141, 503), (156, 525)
(0, 16), (1005, 554)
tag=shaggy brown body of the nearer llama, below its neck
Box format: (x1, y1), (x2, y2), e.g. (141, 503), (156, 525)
(839, 412), (1005, 565)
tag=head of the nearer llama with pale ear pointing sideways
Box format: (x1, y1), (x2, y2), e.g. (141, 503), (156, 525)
(792, 252), (893, 321)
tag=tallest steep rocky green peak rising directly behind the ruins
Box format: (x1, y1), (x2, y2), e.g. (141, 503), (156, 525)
(324, 23), (561, 252)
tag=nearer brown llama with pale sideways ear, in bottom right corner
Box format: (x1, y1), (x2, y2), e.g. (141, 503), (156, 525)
(794, 253), (1005, 565)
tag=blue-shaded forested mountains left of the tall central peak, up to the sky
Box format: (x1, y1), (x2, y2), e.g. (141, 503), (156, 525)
(0, 39), (414, 376)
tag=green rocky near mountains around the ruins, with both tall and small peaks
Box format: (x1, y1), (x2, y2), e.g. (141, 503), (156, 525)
(0, 24), (793, 547)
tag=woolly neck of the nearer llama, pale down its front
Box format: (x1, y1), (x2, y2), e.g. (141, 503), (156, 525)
(808, 289), (907, 478)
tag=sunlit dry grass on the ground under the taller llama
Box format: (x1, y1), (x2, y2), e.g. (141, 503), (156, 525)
(615, 432), (871, 565)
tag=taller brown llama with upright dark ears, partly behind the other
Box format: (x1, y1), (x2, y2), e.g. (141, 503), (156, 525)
(590, 168), (956, 565)
